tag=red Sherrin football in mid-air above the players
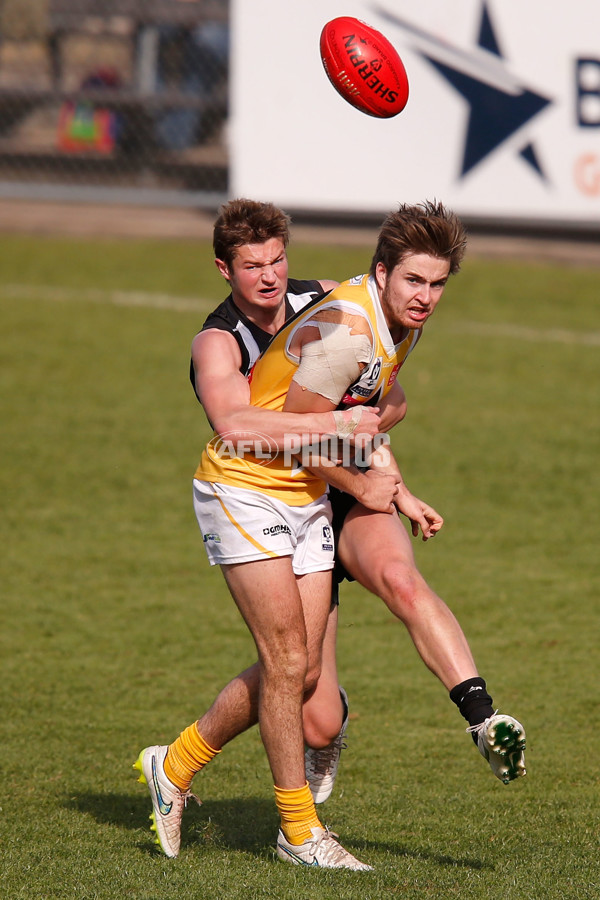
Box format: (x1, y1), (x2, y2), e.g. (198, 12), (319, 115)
(321, 16), (408, 119)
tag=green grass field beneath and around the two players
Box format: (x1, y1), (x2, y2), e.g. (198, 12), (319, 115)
(0, 229), (600, 900)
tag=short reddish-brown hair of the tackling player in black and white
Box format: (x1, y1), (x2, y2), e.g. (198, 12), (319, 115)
(213, 197), (290, 266)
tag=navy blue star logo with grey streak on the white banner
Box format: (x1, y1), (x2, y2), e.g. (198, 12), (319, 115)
(374, 0), (552, 181)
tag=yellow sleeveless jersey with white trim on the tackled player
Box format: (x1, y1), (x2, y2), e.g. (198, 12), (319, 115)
(195, 275), (421, 506)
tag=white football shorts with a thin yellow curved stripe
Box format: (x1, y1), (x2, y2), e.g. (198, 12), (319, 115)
(194, 478), (334, 575)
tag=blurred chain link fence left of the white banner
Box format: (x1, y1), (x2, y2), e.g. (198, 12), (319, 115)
(0, 0), (229, 200)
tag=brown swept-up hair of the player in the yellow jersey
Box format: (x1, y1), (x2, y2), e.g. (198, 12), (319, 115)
(370, 200), (467, 275)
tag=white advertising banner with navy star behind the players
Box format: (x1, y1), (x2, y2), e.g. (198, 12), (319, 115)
(230, 0), (600, 226)
